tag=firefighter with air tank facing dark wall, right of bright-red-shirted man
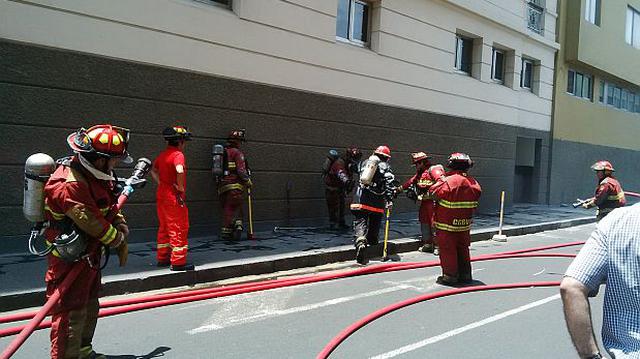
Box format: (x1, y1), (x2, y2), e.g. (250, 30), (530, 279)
(218, 129), (252, 240)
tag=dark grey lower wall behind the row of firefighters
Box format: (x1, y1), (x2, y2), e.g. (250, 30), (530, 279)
(0, 41), (549, 243)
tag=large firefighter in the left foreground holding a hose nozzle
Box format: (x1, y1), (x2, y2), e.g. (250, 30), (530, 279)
(44, 125), (131, 358)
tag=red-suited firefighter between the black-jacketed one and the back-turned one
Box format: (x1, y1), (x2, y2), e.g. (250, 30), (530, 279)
(399, 152), (438, 255)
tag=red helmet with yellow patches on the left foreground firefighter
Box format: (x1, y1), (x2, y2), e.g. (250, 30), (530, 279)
(67, 125), (133, 163)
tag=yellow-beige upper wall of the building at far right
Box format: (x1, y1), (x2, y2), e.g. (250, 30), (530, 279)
(553, 0), (640, 150)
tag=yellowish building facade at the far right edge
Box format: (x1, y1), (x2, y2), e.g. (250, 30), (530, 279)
(549, 0), (640, 207)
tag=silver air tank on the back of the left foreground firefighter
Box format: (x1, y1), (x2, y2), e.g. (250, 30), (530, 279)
(22, 153), (56, 223)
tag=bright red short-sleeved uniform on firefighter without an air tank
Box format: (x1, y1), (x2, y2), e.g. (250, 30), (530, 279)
(153, 146), (189, 267)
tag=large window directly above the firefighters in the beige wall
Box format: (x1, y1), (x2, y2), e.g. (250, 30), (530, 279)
(336, 0), (371, 45)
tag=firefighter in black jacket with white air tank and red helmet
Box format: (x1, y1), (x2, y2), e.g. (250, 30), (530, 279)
(350, 146), (398, 264)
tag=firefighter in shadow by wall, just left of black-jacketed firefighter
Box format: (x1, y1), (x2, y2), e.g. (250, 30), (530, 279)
(324, 147), (362, 230)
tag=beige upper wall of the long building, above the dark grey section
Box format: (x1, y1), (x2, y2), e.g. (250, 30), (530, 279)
(0, 0), (558, 131)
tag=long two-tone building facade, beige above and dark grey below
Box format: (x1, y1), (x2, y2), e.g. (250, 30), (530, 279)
(0, 0), (559, 243)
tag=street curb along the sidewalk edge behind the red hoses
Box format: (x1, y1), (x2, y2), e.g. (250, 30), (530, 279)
(0, 217), (596, 311)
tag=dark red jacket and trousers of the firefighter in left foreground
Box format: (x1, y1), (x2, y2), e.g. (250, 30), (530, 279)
(44, 156), (124, 359)
